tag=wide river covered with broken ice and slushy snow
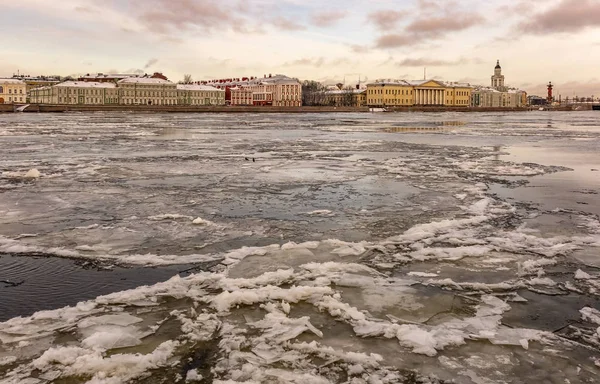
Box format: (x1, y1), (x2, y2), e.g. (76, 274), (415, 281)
(0, 111), (600, 384)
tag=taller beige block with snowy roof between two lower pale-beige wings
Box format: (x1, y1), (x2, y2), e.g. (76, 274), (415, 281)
(118, 77), (177, 105)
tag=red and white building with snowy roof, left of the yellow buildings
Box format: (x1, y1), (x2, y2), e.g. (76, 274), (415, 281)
(202, 75), (302, 107)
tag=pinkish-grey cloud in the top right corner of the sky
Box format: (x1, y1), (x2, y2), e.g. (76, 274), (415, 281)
(519, 0), (600, 35)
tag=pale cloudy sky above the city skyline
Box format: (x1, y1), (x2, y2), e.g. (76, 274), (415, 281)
(0, 0), (600, 98)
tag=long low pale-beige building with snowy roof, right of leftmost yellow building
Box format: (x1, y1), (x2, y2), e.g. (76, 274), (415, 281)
(29, 81), (120, 105)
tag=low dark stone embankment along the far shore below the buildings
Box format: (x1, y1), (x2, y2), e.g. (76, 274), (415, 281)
(0, 104), (591, 113)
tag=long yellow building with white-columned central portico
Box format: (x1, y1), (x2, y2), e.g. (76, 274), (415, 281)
(367, 80), (473, 107)
